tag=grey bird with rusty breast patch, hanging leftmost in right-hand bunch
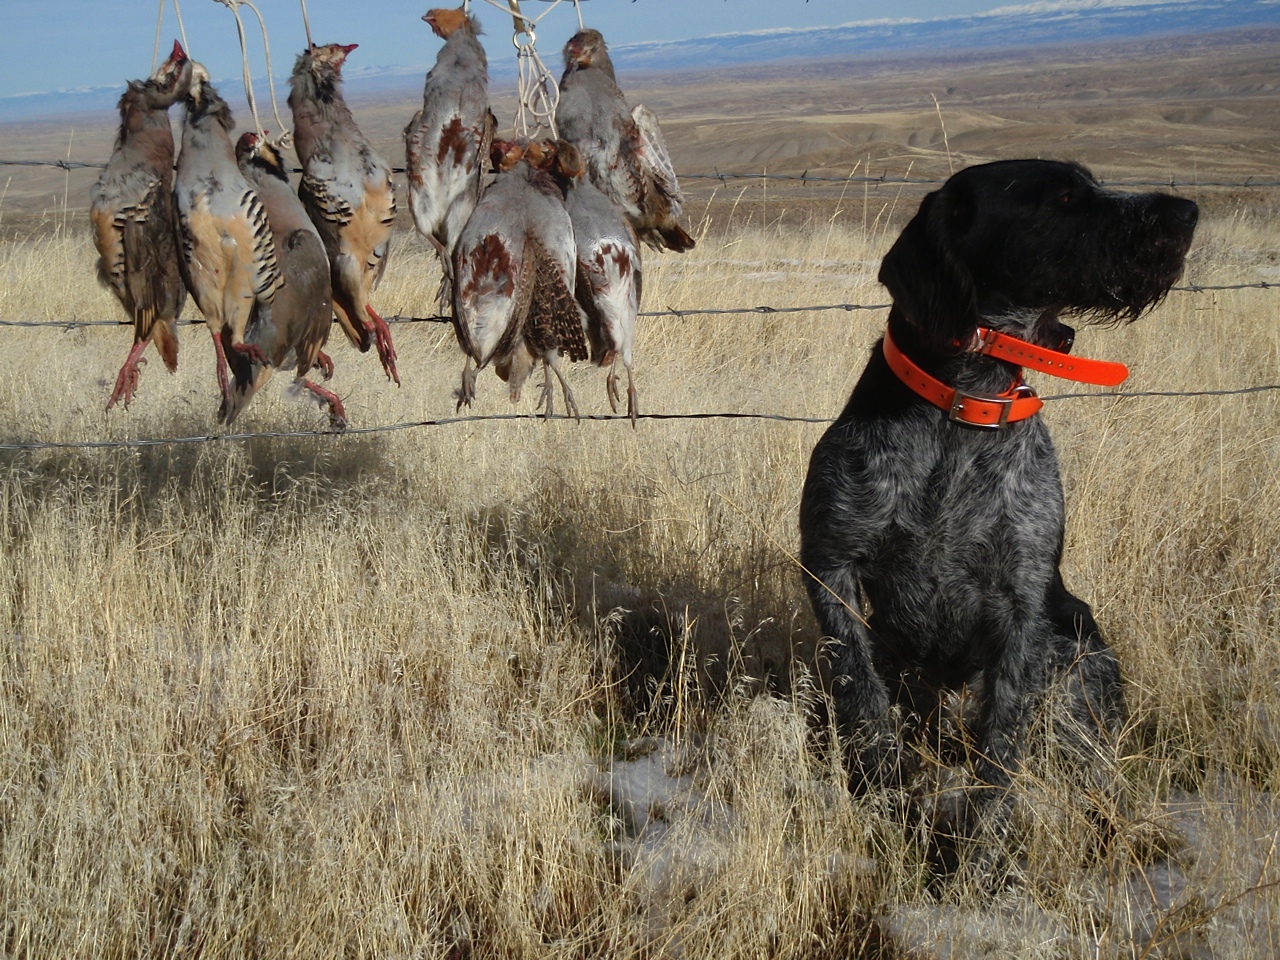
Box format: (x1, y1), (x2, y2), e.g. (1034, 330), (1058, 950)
(404, 8), (498, 308)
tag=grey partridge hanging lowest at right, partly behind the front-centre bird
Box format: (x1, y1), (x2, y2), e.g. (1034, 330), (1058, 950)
(564, 166), (641, 425)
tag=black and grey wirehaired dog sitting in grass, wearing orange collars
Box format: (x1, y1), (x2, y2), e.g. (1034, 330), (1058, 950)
(800, 160), (1198, 869)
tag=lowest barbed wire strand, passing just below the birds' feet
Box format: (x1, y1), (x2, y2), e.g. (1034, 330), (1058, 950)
(0, 384), (1280, 452)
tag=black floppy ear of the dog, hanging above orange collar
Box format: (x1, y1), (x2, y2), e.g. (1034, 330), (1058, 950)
(879, 187), (978, 353)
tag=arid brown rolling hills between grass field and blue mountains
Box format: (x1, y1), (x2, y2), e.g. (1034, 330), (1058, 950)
(0, 31), (1280, 233)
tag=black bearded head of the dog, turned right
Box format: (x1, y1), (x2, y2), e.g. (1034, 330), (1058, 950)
(879, 160), (1198, 353)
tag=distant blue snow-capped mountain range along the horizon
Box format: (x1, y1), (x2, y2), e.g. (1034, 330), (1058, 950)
(0, 0), (1280, 122)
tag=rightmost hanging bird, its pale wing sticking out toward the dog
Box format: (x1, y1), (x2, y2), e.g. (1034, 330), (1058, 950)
(556, 29), (694, 252)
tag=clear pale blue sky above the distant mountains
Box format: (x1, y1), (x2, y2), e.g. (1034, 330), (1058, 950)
(0, 0), (1007, 99)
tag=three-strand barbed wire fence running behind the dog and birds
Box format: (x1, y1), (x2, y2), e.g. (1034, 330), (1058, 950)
(0, 159), (1280, 452)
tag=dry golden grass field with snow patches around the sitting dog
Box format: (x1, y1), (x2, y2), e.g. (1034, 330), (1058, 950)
(0, 30), (1280, 960)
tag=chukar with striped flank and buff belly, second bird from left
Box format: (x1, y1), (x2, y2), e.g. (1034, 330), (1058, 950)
(174, 60), (280, 420)
